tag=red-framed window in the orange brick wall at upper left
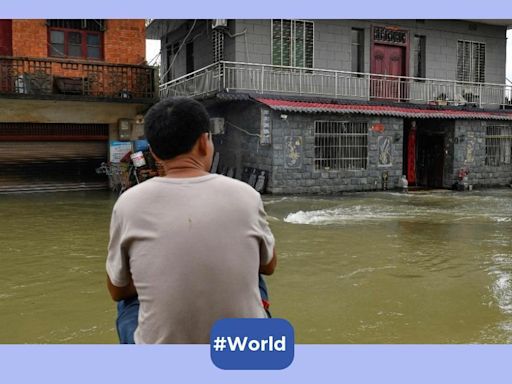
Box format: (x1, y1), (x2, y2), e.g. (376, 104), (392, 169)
(47, 19), (104, 60)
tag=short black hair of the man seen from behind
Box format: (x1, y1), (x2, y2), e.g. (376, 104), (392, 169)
(144, 97), (210, 160)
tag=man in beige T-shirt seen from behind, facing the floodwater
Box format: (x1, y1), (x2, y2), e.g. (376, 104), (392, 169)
(107, 98), (276, 343)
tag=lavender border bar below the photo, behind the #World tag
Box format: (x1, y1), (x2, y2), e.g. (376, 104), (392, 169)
(0, 345), (512, 384)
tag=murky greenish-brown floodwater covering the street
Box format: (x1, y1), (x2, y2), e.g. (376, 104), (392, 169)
(0, 189), (512, 343)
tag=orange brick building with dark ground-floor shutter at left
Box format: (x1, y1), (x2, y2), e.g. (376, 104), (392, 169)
(0, 19), (158, 192)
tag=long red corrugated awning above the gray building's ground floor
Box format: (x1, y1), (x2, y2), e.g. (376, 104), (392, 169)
(256, 98), (512, 121)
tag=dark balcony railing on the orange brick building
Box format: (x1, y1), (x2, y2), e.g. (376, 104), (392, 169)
(0, 57), (158, 100)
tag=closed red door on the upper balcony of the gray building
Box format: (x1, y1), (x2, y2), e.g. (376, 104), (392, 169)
(370, 44), (405, 101)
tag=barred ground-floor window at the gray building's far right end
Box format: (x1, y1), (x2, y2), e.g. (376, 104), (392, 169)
(485, 125), (512, 167)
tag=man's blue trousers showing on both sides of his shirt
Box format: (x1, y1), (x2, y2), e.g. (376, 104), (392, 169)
(116, 275), (272, 344)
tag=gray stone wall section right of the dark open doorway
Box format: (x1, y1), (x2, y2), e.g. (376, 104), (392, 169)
(452, 120), (512, 187)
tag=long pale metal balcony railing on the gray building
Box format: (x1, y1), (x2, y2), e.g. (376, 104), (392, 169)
(160, 62), (512, 108)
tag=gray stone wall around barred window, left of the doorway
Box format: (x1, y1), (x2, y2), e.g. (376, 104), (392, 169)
(270, 112), (403, 193)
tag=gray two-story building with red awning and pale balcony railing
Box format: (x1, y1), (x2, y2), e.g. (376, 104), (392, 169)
(147, 19), (512, 193)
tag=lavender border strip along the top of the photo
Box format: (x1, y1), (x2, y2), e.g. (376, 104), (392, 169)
(0, 0), (512, 19)
